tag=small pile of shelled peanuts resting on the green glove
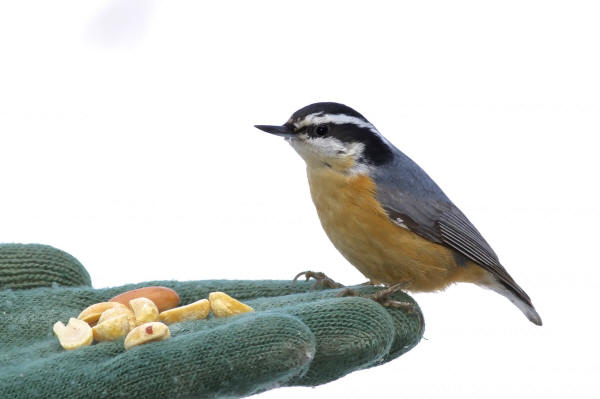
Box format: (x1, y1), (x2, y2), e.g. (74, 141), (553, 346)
(53, 287), (253, 350)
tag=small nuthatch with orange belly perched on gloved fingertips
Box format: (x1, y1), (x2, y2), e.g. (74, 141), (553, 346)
(255, 102), (542, 326)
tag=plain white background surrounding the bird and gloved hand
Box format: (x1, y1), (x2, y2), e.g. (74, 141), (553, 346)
(0, 0), (600, 398)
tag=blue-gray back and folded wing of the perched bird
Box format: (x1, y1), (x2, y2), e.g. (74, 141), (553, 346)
(372, 150), (529, 299)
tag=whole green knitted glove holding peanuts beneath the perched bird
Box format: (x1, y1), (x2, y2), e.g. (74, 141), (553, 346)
(0, 244), (423, 398)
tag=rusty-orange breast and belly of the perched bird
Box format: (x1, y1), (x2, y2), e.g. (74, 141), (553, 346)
(309, 169), (483, 291)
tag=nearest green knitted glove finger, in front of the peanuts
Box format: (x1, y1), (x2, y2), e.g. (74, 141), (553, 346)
(0, 313), (315, 398)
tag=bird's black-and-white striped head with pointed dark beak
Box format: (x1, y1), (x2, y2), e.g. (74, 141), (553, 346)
(256, 102), (394, 173)
